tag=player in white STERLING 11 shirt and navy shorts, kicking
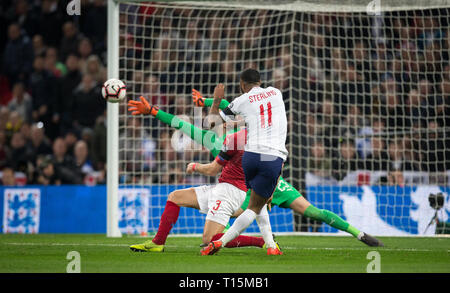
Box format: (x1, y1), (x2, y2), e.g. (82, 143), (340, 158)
(201, 69), (288, 255)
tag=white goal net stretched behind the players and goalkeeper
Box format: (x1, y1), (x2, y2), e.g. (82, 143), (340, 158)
(111, 0), (450, 235)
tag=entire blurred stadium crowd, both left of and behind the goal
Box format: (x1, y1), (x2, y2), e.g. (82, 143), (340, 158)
(0, 0), (450, 185)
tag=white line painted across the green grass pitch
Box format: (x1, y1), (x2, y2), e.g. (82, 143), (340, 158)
(0, 242), (450, 252)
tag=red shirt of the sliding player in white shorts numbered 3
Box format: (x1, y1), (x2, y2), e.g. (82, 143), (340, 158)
(216, 129), (248, 192)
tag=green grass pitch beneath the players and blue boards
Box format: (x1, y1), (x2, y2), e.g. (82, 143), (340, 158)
(0, 234), (450, 273)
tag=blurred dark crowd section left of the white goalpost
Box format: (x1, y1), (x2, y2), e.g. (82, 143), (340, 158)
(0, 0), (106, 185)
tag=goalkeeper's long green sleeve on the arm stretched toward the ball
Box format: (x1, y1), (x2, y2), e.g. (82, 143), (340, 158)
(155, 109), (222, 157)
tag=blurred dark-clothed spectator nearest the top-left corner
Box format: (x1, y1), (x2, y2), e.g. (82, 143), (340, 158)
(3, 23), (33, 83)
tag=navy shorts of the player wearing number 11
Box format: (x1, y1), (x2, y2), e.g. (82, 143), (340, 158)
(242, 152), (283, 198)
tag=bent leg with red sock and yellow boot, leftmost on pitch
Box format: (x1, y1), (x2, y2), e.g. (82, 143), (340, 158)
(130, 188), (200, 252)
